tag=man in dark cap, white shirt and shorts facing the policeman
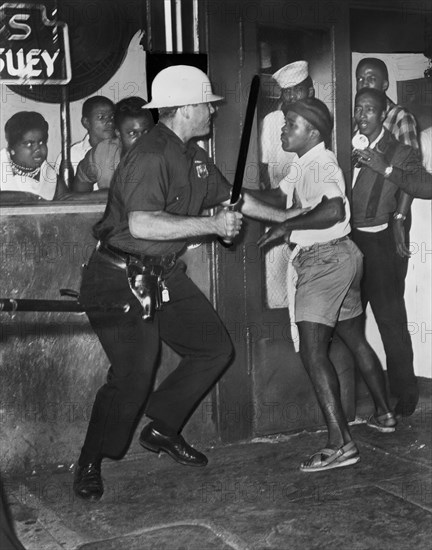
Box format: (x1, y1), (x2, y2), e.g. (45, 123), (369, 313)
(258, 98), (396, 472)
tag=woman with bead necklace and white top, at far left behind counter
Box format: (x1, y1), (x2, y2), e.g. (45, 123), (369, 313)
(0, 111), (68, 202)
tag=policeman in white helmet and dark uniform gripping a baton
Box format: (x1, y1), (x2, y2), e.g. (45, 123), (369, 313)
(74, 65), (308, 500)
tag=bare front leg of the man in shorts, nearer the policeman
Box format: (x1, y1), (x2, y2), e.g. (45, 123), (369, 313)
(297, 321), (351, 449)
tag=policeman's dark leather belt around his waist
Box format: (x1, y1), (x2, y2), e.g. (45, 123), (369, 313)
(96, 241), (177, 276)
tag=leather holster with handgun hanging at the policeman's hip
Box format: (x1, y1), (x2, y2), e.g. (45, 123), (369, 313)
(126, 257), (169, 321)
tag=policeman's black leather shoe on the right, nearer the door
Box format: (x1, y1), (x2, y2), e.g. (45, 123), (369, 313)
(139, 424), (208, 466)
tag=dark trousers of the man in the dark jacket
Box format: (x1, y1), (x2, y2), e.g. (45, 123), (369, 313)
(352, 226), (417, 398)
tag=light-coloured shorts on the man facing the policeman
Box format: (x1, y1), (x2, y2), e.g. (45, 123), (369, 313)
(293, 237), (363, 327)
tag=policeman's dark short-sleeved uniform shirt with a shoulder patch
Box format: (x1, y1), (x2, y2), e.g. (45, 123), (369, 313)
(94, 122), (231, 256)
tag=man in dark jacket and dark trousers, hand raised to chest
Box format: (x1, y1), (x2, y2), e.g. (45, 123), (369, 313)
(352, 88), (432, 416)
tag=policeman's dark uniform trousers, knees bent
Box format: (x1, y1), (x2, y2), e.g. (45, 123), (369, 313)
(80, 250), (233, 463)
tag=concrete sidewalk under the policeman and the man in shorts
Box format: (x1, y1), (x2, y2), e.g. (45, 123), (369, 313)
(6, 386), (432, 550)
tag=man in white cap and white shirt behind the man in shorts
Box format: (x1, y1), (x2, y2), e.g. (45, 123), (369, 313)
(260, 60), (315, 194)
